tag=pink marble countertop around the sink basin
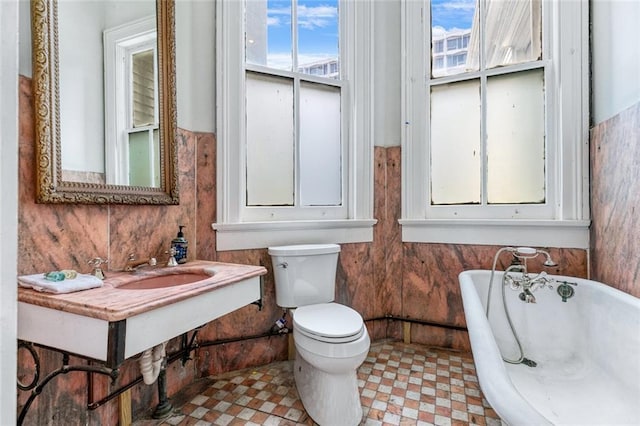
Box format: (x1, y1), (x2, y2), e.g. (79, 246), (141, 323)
(18, 260), (267, 321)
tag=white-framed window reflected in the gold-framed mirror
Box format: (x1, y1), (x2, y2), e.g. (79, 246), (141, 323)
(104, 18), (160, 187)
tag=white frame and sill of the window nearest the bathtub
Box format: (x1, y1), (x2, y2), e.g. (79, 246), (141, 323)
(400, 0), (589, 249)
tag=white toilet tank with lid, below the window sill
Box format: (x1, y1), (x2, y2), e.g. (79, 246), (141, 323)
(269, 244), (340, 308)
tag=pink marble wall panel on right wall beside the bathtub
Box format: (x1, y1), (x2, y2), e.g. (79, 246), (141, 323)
(591, 103), (640, 297)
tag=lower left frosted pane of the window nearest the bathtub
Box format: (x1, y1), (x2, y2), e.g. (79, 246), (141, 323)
(431, 80), (481, 205)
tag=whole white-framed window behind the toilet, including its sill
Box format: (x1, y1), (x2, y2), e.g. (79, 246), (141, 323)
(213, 0), (375, 250)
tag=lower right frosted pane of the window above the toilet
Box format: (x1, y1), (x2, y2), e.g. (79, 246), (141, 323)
(300, 83), (342, 206)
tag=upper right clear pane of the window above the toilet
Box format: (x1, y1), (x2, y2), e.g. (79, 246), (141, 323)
(297, 0), (339, 78)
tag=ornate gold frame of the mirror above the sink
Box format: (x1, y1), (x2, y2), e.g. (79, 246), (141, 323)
(31, 0), (180, 204)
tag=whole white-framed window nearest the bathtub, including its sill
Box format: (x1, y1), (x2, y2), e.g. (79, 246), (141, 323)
(401, 0), (588, 247)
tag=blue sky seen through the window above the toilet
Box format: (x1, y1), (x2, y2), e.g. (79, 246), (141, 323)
(267, 0), (338, 64)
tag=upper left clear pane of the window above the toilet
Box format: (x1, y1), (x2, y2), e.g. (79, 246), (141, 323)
(245, 0), (293, 71)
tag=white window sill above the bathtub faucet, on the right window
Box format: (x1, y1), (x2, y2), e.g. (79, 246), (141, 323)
(399, 219), (590, 249)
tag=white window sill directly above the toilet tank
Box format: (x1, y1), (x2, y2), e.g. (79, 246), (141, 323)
(211, 219), (377, 251)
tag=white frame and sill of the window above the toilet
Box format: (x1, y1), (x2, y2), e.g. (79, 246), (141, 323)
(212, 0), (376, 251)
